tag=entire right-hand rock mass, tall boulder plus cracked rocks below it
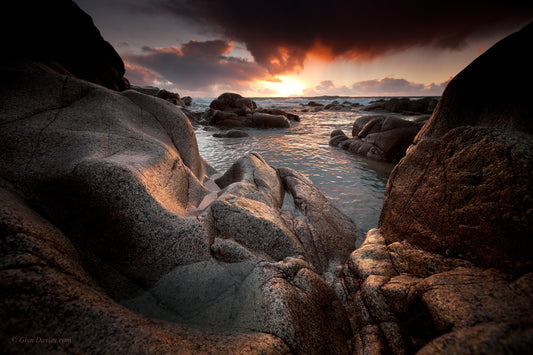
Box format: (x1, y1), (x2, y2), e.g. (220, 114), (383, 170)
(336, 24), (533, 354)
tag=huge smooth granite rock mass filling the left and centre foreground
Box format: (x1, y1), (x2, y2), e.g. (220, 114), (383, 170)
(0, 62), (360, 354)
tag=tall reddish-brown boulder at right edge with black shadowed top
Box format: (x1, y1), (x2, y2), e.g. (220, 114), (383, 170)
(380, 20), (533, 274)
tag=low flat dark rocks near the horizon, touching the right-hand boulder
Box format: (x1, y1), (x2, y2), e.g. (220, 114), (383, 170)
(362, 97), (439, 115)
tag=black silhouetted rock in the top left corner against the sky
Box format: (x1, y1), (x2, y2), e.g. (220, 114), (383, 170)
(0, 0), (129, 91)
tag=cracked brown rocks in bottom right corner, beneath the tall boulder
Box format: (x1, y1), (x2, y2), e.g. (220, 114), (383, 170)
(343, 229), (533, 354)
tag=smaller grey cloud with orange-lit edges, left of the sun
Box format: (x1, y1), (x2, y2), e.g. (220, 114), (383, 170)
(123, 40), (270, 90)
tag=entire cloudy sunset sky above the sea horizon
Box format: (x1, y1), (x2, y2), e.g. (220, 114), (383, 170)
(74, 0), (533, 98)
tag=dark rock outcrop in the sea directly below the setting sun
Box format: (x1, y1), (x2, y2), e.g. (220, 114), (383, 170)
(201, 93), (300, 128)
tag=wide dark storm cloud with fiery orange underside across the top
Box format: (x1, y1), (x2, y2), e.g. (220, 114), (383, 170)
(151, 0), (533, 74)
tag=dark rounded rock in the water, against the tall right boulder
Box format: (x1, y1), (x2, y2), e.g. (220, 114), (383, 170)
(329, 115), (429, 162)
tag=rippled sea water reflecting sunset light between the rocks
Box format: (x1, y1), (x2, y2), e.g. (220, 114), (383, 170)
(193, 98), (393, 233)
